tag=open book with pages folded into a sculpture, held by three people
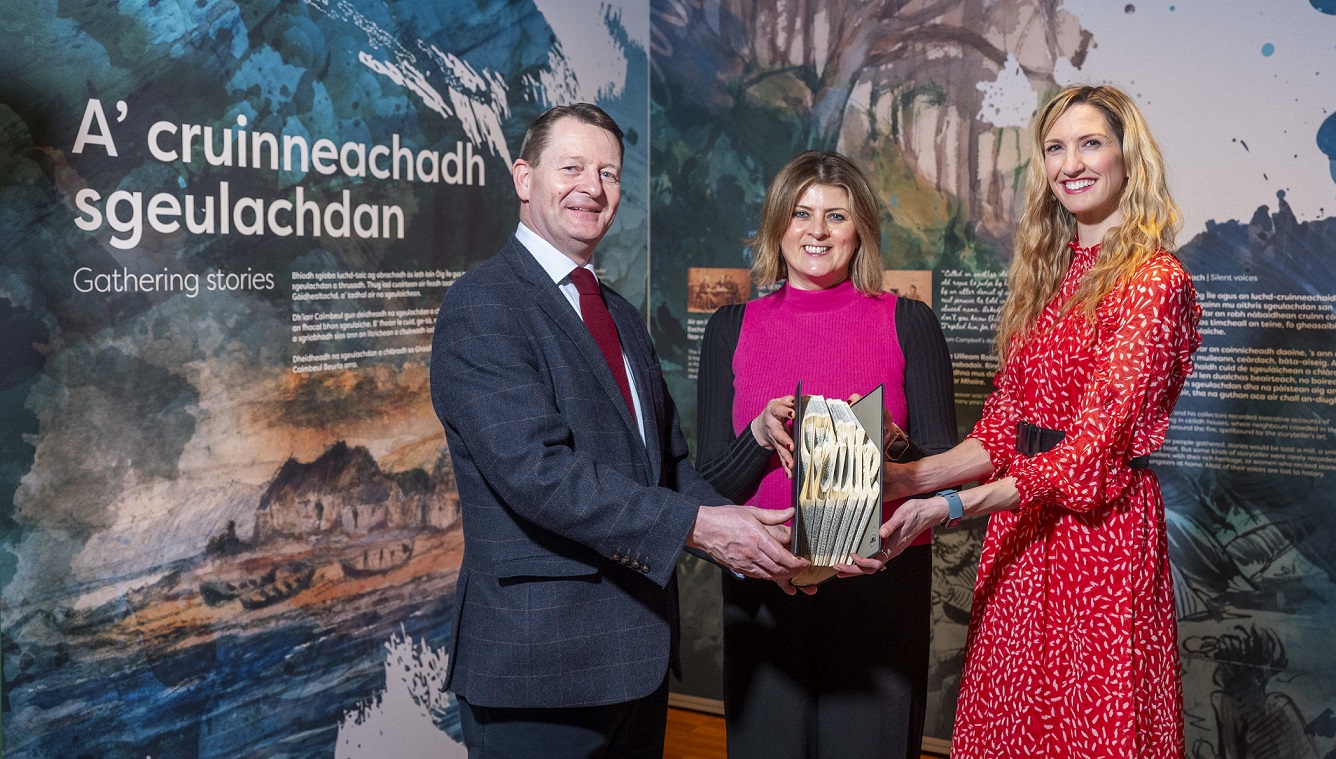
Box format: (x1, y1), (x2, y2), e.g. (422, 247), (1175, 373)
(794, 384), (884, 585)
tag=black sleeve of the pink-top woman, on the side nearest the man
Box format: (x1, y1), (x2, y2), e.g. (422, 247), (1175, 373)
(696, 305), (774, 504)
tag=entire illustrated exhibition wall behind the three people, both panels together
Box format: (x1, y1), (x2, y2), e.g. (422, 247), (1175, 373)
(0, 0), (1336, 759)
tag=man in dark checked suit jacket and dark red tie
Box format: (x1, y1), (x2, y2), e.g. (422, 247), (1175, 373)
(432, 104), (806, 759)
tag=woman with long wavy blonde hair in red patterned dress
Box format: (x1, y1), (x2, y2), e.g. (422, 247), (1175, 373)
(844, 86), (1201, 759)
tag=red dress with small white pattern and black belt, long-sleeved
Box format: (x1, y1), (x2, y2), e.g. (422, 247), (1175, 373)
(951, 243), (1201, 759)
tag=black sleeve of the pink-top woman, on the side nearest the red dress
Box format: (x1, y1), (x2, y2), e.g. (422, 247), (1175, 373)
(895, 298), (958, 456)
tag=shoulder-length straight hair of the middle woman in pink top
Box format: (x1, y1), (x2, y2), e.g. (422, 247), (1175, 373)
(747, 150), (882, 295)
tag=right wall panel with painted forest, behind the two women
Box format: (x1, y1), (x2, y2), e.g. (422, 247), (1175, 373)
(651, 0), (1336, 759)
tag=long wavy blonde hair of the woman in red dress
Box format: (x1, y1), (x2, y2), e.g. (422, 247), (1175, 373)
(997, 84), (1182, 365)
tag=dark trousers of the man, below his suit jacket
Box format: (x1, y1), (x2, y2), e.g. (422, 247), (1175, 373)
(457, 676), (668, 759)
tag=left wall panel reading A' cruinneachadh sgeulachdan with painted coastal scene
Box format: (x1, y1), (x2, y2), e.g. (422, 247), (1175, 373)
(0, 0), (649, 759)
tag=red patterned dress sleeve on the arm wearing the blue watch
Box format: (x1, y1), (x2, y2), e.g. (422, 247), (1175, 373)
(1007, 253), (1201, 512)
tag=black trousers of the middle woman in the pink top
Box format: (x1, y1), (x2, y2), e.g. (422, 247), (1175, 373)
(723, 545), (933, 759)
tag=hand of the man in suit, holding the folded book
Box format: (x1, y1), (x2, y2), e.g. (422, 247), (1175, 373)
(687, 505), (810, 585)
